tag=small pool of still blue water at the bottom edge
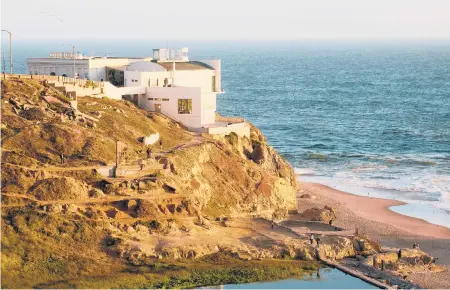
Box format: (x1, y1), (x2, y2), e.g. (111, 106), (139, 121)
(203, 268), (378, 289)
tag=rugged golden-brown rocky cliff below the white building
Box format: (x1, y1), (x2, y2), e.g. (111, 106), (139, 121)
(1, 80), (297, 287)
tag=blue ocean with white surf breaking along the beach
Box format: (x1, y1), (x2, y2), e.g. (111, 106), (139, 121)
(4, 40), (450, 227)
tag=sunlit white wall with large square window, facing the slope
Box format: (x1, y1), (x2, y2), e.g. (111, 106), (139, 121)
(139, 87), (202, 128)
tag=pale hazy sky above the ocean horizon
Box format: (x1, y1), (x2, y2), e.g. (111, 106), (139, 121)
(1, 0), (450, 40)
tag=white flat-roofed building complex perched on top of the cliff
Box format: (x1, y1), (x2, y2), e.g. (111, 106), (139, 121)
(27, 48), (250, 137)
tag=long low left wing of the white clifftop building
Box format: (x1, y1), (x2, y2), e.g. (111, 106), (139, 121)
(27, 52), (151, 81)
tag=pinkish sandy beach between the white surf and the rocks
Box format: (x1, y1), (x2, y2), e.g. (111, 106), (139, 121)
(298, 182), (450, 288)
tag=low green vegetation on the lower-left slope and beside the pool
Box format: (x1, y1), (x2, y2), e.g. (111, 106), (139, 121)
(1, 209), (320, 288)
